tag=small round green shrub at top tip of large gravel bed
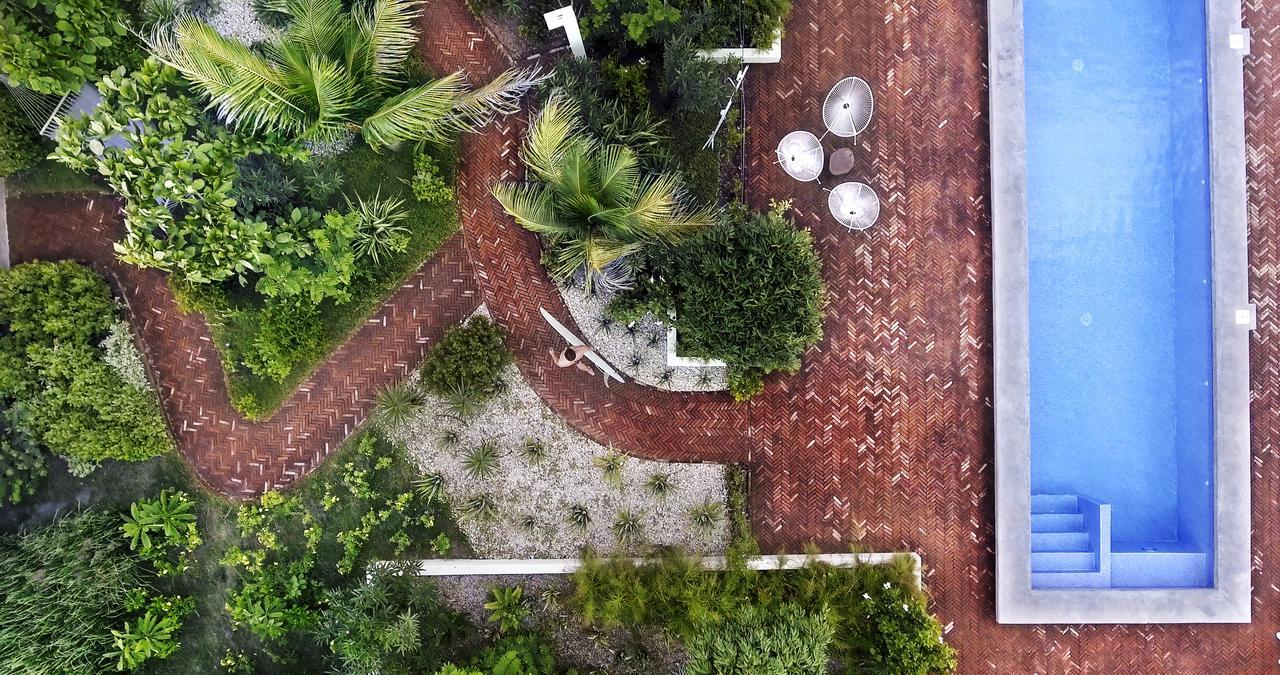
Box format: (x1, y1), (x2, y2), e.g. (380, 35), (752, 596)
(422, 316), (512, 397)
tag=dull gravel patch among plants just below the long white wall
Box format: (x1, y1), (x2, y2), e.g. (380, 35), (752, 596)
(433, 575), (687, 675)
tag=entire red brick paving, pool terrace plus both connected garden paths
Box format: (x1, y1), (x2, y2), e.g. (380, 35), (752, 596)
(10, 0), (1280, 672)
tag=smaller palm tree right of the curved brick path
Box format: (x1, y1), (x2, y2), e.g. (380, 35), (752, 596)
(493, 92), (712, 289)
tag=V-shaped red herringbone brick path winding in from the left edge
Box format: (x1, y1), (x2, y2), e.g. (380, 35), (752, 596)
(9, 195), (479, 497)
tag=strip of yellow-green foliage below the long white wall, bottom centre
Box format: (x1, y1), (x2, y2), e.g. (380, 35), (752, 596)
(570, 553), (955, 675)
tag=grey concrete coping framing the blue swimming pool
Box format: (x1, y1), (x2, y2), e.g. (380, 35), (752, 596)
(988, 0), (1254, 624)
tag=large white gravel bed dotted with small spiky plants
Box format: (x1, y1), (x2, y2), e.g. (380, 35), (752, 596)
(389, 320), (728, 557)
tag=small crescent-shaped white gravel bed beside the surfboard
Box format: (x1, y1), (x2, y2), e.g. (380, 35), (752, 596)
(561, 286), (728, 392)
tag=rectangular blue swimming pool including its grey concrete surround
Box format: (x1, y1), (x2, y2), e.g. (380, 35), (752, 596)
(988, 0), (1253, 622)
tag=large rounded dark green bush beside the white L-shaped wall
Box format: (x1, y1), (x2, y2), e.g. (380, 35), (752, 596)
(612, 206), (826, 400)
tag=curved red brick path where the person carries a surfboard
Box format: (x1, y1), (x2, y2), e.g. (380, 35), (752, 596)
(424, 1), (748, 461)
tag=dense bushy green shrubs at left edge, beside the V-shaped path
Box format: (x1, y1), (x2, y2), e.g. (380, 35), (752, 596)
(0, 261), (173, 502)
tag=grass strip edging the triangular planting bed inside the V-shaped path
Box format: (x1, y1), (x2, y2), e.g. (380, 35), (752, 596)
(175, 145), (458, 420)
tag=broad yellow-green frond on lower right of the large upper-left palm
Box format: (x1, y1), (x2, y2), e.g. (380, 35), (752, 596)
(361, 72), (467, 149)
